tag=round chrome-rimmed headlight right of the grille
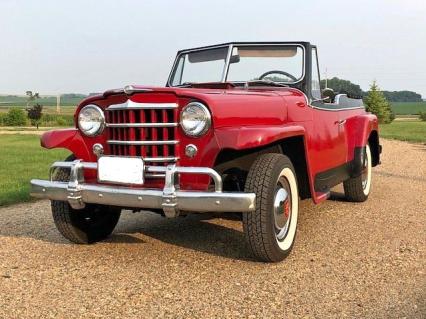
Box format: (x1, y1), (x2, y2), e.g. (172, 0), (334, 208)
(180, 102), (211, 136)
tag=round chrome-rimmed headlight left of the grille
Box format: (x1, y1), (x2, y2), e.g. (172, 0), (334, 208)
(78, 104), (105, 136)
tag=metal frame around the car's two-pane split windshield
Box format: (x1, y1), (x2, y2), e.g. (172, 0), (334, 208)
(166, 42), (307, 87)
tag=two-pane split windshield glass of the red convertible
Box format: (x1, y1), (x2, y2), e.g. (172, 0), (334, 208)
(170, 45), (304, 86)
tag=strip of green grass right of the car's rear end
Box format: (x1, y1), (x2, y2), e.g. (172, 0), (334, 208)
(379, 121), (426, 143)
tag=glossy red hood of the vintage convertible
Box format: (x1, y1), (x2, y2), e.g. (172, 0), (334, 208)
(82, 85), (303, 127)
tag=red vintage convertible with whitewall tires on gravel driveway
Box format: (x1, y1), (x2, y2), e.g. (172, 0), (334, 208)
(31, 42), (381, 262)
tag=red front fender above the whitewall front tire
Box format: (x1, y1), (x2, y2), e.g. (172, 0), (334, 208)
(215, 125), (305, 150)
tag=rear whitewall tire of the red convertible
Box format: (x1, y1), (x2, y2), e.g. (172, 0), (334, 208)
(343, 144), (372, 202)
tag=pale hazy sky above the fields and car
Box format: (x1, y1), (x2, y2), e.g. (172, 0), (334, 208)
(0, 0), (426, 98)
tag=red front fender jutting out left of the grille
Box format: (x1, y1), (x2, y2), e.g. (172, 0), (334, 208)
(40, 128), (94, 161)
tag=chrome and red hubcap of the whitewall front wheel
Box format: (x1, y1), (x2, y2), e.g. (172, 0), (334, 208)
(274, 180), (291, 240)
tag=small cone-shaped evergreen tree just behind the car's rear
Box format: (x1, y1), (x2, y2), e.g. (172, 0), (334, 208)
(365, 81), (394, 123)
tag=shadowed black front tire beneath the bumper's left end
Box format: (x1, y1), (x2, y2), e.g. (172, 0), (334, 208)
(51, 156), (121, 244)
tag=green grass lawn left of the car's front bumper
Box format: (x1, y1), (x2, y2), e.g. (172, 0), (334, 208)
(0, 135), (69, 206)
